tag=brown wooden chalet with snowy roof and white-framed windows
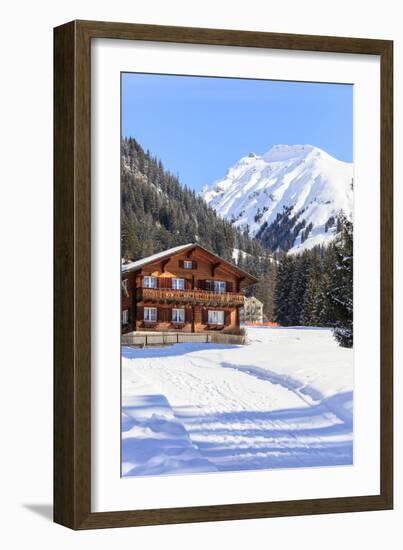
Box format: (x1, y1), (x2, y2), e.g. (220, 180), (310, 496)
(122, 244), (257, 334)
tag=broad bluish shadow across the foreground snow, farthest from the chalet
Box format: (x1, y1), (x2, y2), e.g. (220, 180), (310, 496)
(122, 392), (353, 476)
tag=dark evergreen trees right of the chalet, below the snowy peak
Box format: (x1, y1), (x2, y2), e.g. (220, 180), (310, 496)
(273, 212), (353, 347)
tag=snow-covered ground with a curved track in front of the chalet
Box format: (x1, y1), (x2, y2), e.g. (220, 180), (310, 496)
(122, 327), (353, 476)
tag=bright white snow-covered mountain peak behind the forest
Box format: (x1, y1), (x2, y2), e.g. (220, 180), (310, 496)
(202, 145), (353, 252)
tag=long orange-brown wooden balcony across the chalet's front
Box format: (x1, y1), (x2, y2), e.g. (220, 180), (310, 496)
(136, 288), (244, 307)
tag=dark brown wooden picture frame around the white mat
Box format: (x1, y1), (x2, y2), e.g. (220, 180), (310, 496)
(54, 21), (393, 529)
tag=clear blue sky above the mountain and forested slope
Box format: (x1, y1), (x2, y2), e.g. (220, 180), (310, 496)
(122, 73), (353, 191)
